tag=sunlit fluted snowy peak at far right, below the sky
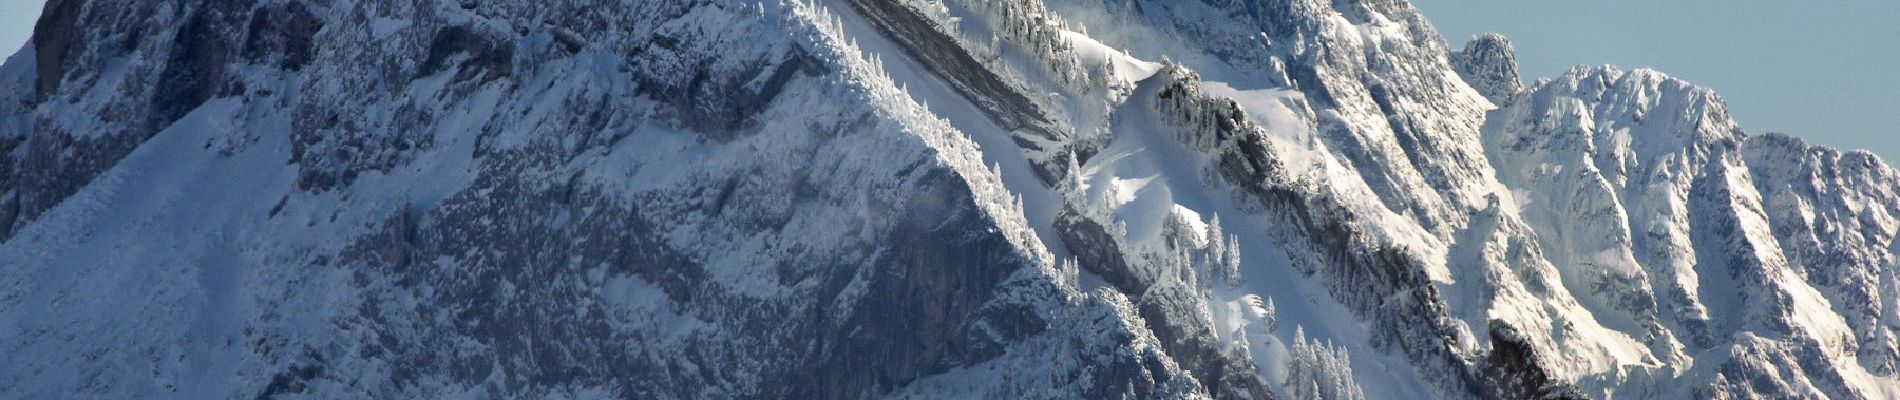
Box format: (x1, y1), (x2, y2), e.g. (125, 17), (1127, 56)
(1488, 66), (1900, 398)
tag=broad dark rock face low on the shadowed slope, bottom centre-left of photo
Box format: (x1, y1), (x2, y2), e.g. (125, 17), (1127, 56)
(313, 152), (1045, 398)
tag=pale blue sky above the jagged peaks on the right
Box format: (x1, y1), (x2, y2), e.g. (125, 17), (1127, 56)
(1412, 0), (1900, 165)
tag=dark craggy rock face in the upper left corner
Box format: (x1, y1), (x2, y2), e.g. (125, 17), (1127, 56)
(0, 0), (300, 239)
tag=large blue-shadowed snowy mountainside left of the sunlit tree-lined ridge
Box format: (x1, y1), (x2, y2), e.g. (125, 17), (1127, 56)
(0, 2), (1201, 398)
